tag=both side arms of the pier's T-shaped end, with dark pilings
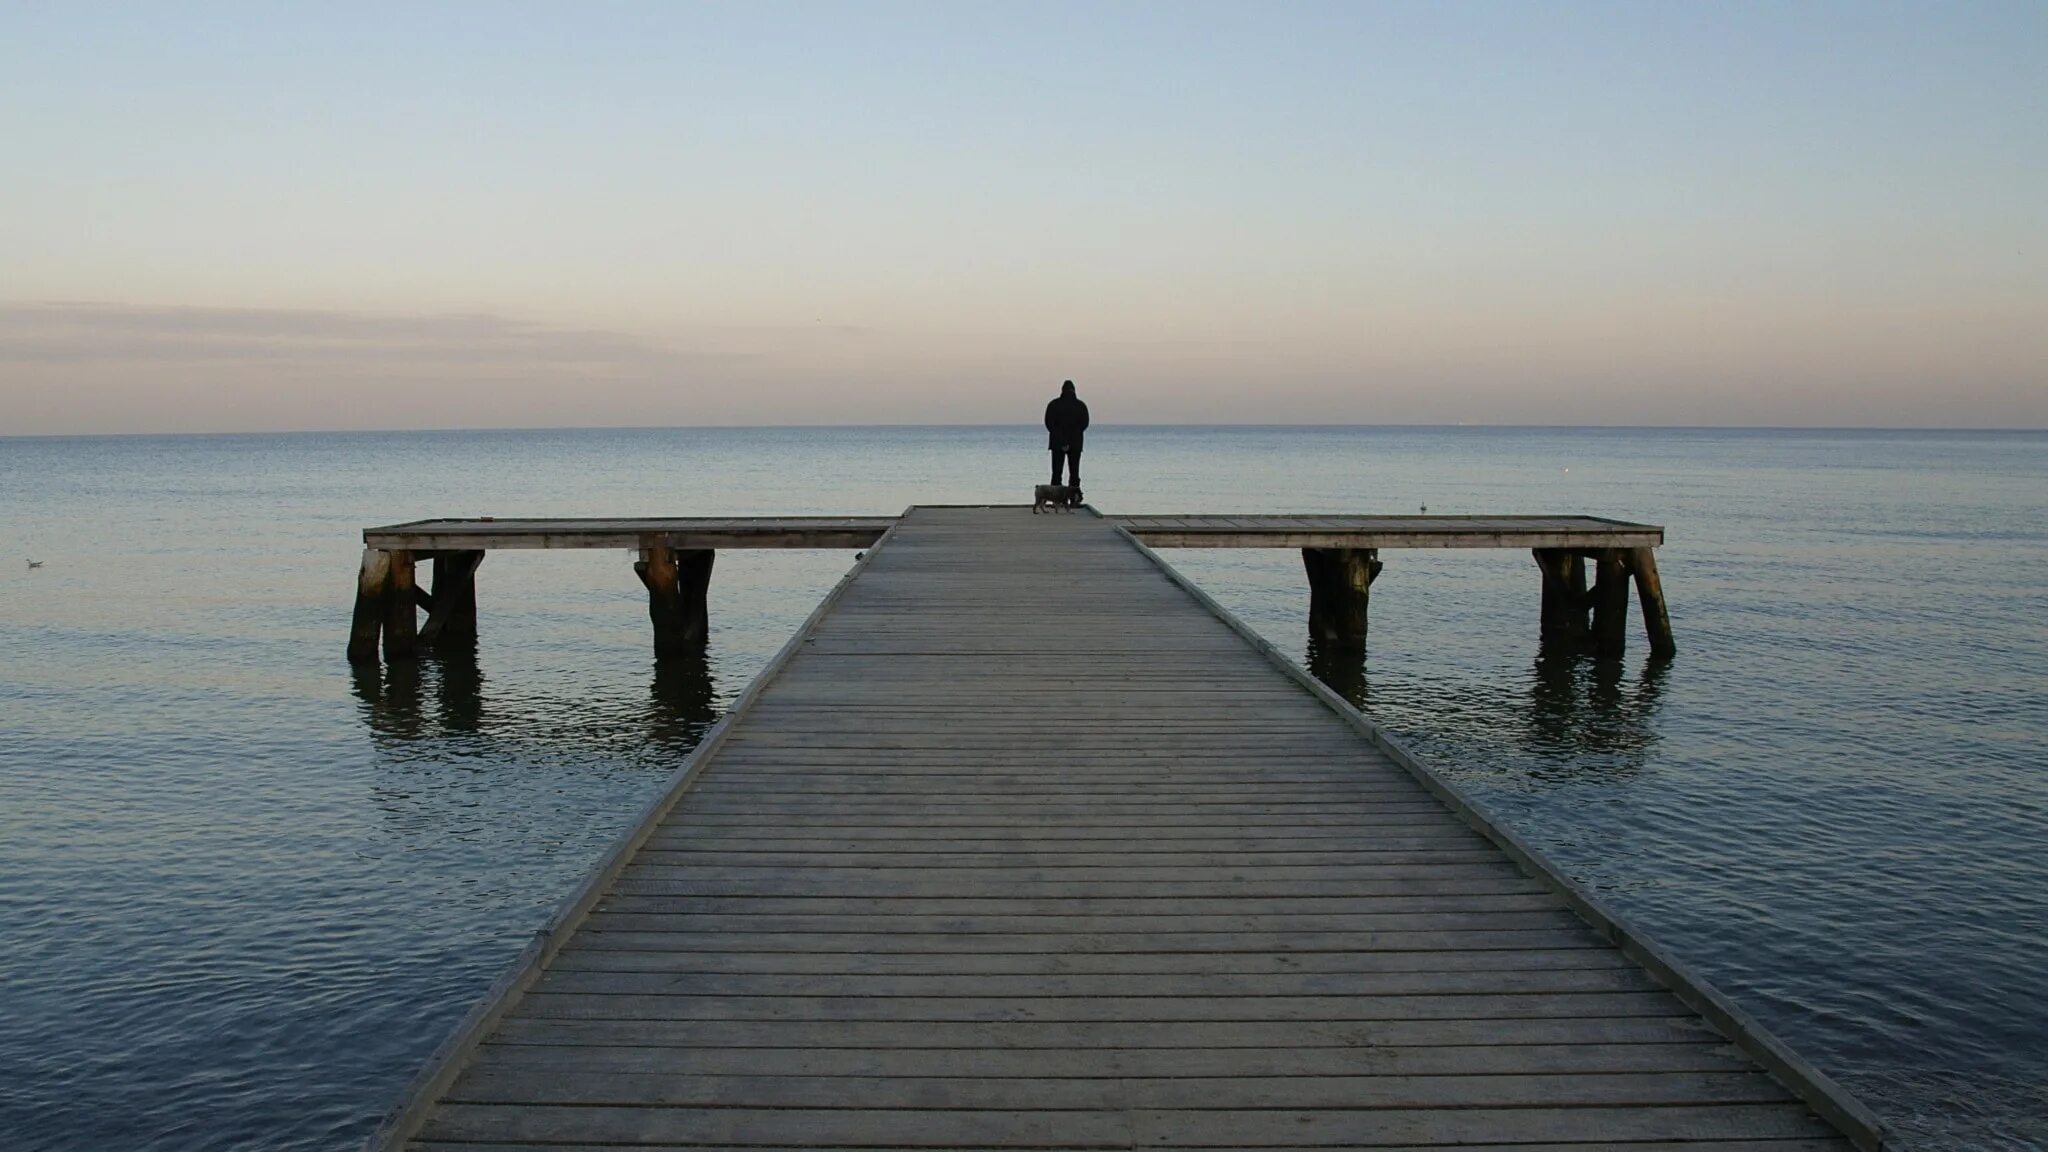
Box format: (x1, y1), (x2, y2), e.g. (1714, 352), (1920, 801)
(348, 517), (1677, 664)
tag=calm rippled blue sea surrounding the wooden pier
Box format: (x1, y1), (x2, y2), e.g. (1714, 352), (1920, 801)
(0, 426), (2048, 1150)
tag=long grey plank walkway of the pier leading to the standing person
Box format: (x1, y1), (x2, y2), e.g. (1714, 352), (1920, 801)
(373, 508), (1882, 1152)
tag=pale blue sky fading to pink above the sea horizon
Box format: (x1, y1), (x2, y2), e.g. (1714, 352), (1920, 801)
(0, 0), (2048, 435)
